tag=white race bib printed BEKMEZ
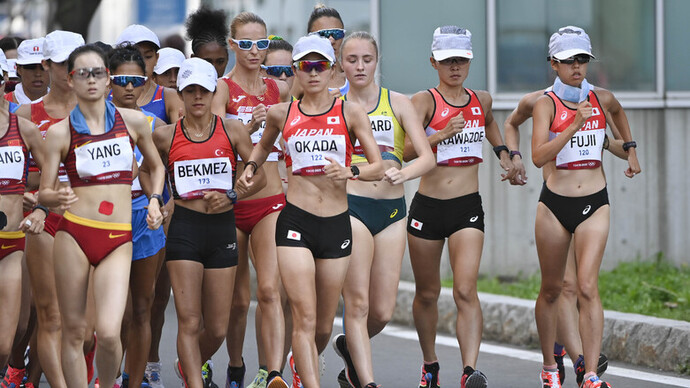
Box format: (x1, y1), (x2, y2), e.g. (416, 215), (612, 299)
(174, 157), (232, 199)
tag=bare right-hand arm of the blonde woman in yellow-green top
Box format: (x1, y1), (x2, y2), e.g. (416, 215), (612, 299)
(384, 91), (436, 184)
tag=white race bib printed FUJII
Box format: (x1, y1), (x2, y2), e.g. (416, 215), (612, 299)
(556, 129), (606, 169)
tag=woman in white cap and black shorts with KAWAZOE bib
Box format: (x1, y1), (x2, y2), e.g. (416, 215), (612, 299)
(406, 26), (515, 388)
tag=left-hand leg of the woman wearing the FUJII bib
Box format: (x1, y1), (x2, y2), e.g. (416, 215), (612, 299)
(534, 202), (571, 366)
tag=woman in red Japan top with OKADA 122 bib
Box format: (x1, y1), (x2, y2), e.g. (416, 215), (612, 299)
(241, 35), (383, 388)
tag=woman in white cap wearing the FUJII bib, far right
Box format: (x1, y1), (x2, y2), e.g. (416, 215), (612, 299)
(532, 26), (640, 388)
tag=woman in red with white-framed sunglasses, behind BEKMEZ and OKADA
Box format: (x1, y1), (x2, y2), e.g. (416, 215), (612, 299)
(207, 12), (290, 387)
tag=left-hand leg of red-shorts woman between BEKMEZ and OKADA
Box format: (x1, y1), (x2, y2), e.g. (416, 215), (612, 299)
(226, 229), (251, 368)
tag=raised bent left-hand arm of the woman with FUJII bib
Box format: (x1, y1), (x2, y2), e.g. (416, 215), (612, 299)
(532, 96), (592, 168)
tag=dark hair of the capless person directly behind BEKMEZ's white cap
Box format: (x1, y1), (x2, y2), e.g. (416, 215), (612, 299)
(184, 6), (230, 54)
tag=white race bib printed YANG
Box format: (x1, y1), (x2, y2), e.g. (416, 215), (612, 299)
(74, 136), (134, 179)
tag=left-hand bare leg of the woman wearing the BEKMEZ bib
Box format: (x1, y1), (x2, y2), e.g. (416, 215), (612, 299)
(166, 260), (204, 388)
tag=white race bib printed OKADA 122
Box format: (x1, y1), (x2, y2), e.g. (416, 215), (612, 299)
(288, 135), (346, 175)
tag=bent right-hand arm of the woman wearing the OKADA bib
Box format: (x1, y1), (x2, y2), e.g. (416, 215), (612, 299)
(336, 101), (384, 181)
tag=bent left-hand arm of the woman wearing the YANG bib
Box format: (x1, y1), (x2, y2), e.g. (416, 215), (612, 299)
(38, 120), (79, 210)
